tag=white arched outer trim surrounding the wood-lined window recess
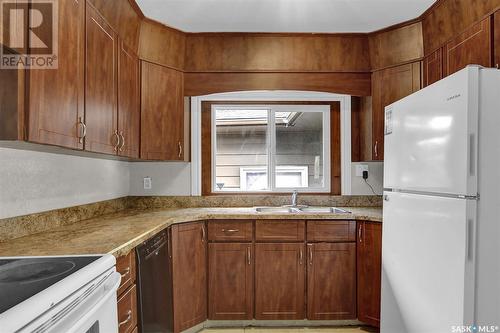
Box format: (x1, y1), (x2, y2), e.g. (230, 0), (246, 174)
(191, 90), (351, 196)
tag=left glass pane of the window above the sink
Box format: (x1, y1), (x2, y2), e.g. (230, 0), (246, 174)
(215, 109), (269, 191)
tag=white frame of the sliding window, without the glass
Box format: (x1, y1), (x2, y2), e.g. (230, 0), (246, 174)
(210, 103), (331, 194)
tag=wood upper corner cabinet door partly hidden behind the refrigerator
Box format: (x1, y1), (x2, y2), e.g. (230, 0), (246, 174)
(372, 62), (421, 160)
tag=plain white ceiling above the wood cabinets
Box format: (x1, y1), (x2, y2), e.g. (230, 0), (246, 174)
(136, 0), (435, 33)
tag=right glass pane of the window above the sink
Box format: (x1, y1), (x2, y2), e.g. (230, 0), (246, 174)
(275, 112), (324, 188)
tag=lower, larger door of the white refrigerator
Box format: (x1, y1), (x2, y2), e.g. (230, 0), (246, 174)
(381, 192), (476, 333)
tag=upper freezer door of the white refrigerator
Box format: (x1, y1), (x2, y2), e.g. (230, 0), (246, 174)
(384, 66), (480, 196)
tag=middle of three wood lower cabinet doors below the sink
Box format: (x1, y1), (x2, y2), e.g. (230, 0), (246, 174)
(255, 243), (305, 320)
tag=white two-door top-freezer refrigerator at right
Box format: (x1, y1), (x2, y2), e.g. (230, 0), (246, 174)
(381, 66), (500, 333)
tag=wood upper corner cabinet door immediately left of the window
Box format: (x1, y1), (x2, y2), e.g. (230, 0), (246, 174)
(141, 61), (185, 161)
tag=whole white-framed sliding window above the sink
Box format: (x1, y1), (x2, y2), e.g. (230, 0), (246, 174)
(211, 104), (330, 193)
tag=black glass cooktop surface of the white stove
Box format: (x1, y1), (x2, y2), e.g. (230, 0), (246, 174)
(0, 256), (100, 313)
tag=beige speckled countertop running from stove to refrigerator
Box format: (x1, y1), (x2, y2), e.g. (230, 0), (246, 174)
(0, 207), (382, 257)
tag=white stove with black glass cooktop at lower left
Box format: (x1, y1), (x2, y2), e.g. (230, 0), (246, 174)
(0, 255), (121, 333)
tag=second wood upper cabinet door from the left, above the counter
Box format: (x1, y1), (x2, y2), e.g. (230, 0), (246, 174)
(85, 4), (119, 154)
